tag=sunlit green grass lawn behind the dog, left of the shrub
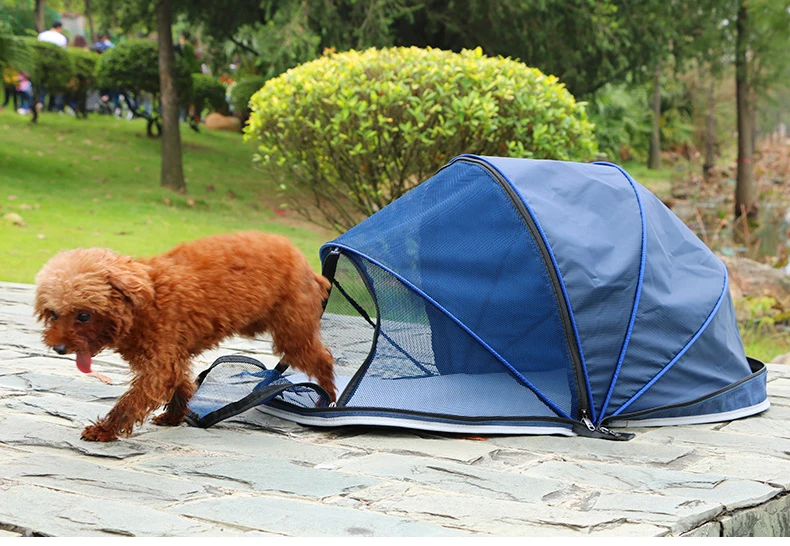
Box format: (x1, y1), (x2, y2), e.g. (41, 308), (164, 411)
(0, 109), (334, 283)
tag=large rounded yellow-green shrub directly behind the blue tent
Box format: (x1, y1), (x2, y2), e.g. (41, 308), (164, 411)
(245, 47), (596, 229)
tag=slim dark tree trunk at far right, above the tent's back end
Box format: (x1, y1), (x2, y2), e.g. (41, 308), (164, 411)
(735, 1), (759, 218)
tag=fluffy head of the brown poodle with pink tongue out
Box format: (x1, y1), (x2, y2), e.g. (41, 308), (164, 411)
(35, 248), (154, 373)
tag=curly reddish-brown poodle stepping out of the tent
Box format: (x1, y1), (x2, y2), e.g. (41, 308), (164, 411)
(35, 232), (335, 442)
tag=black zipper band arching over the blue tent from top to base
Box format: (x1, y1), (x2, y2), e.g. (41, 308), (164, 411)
(446, 157), (595, 422)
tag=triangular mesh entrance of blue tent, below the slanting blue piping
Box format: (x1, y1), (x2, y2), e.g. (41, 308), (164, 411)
(322, 255), (567, 417)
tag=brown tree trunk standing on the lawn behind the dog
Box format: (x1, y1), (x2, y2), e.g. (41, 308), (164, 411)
(156, 0), (186, 192)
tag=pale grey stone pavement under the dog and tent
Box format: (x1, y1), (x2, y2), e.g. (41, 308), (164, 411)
(0, 283), (790, 537)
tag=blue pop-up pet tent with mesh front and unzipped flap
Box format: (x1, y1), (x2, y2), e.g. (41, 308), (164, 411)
(192, 155), (769, 438)
